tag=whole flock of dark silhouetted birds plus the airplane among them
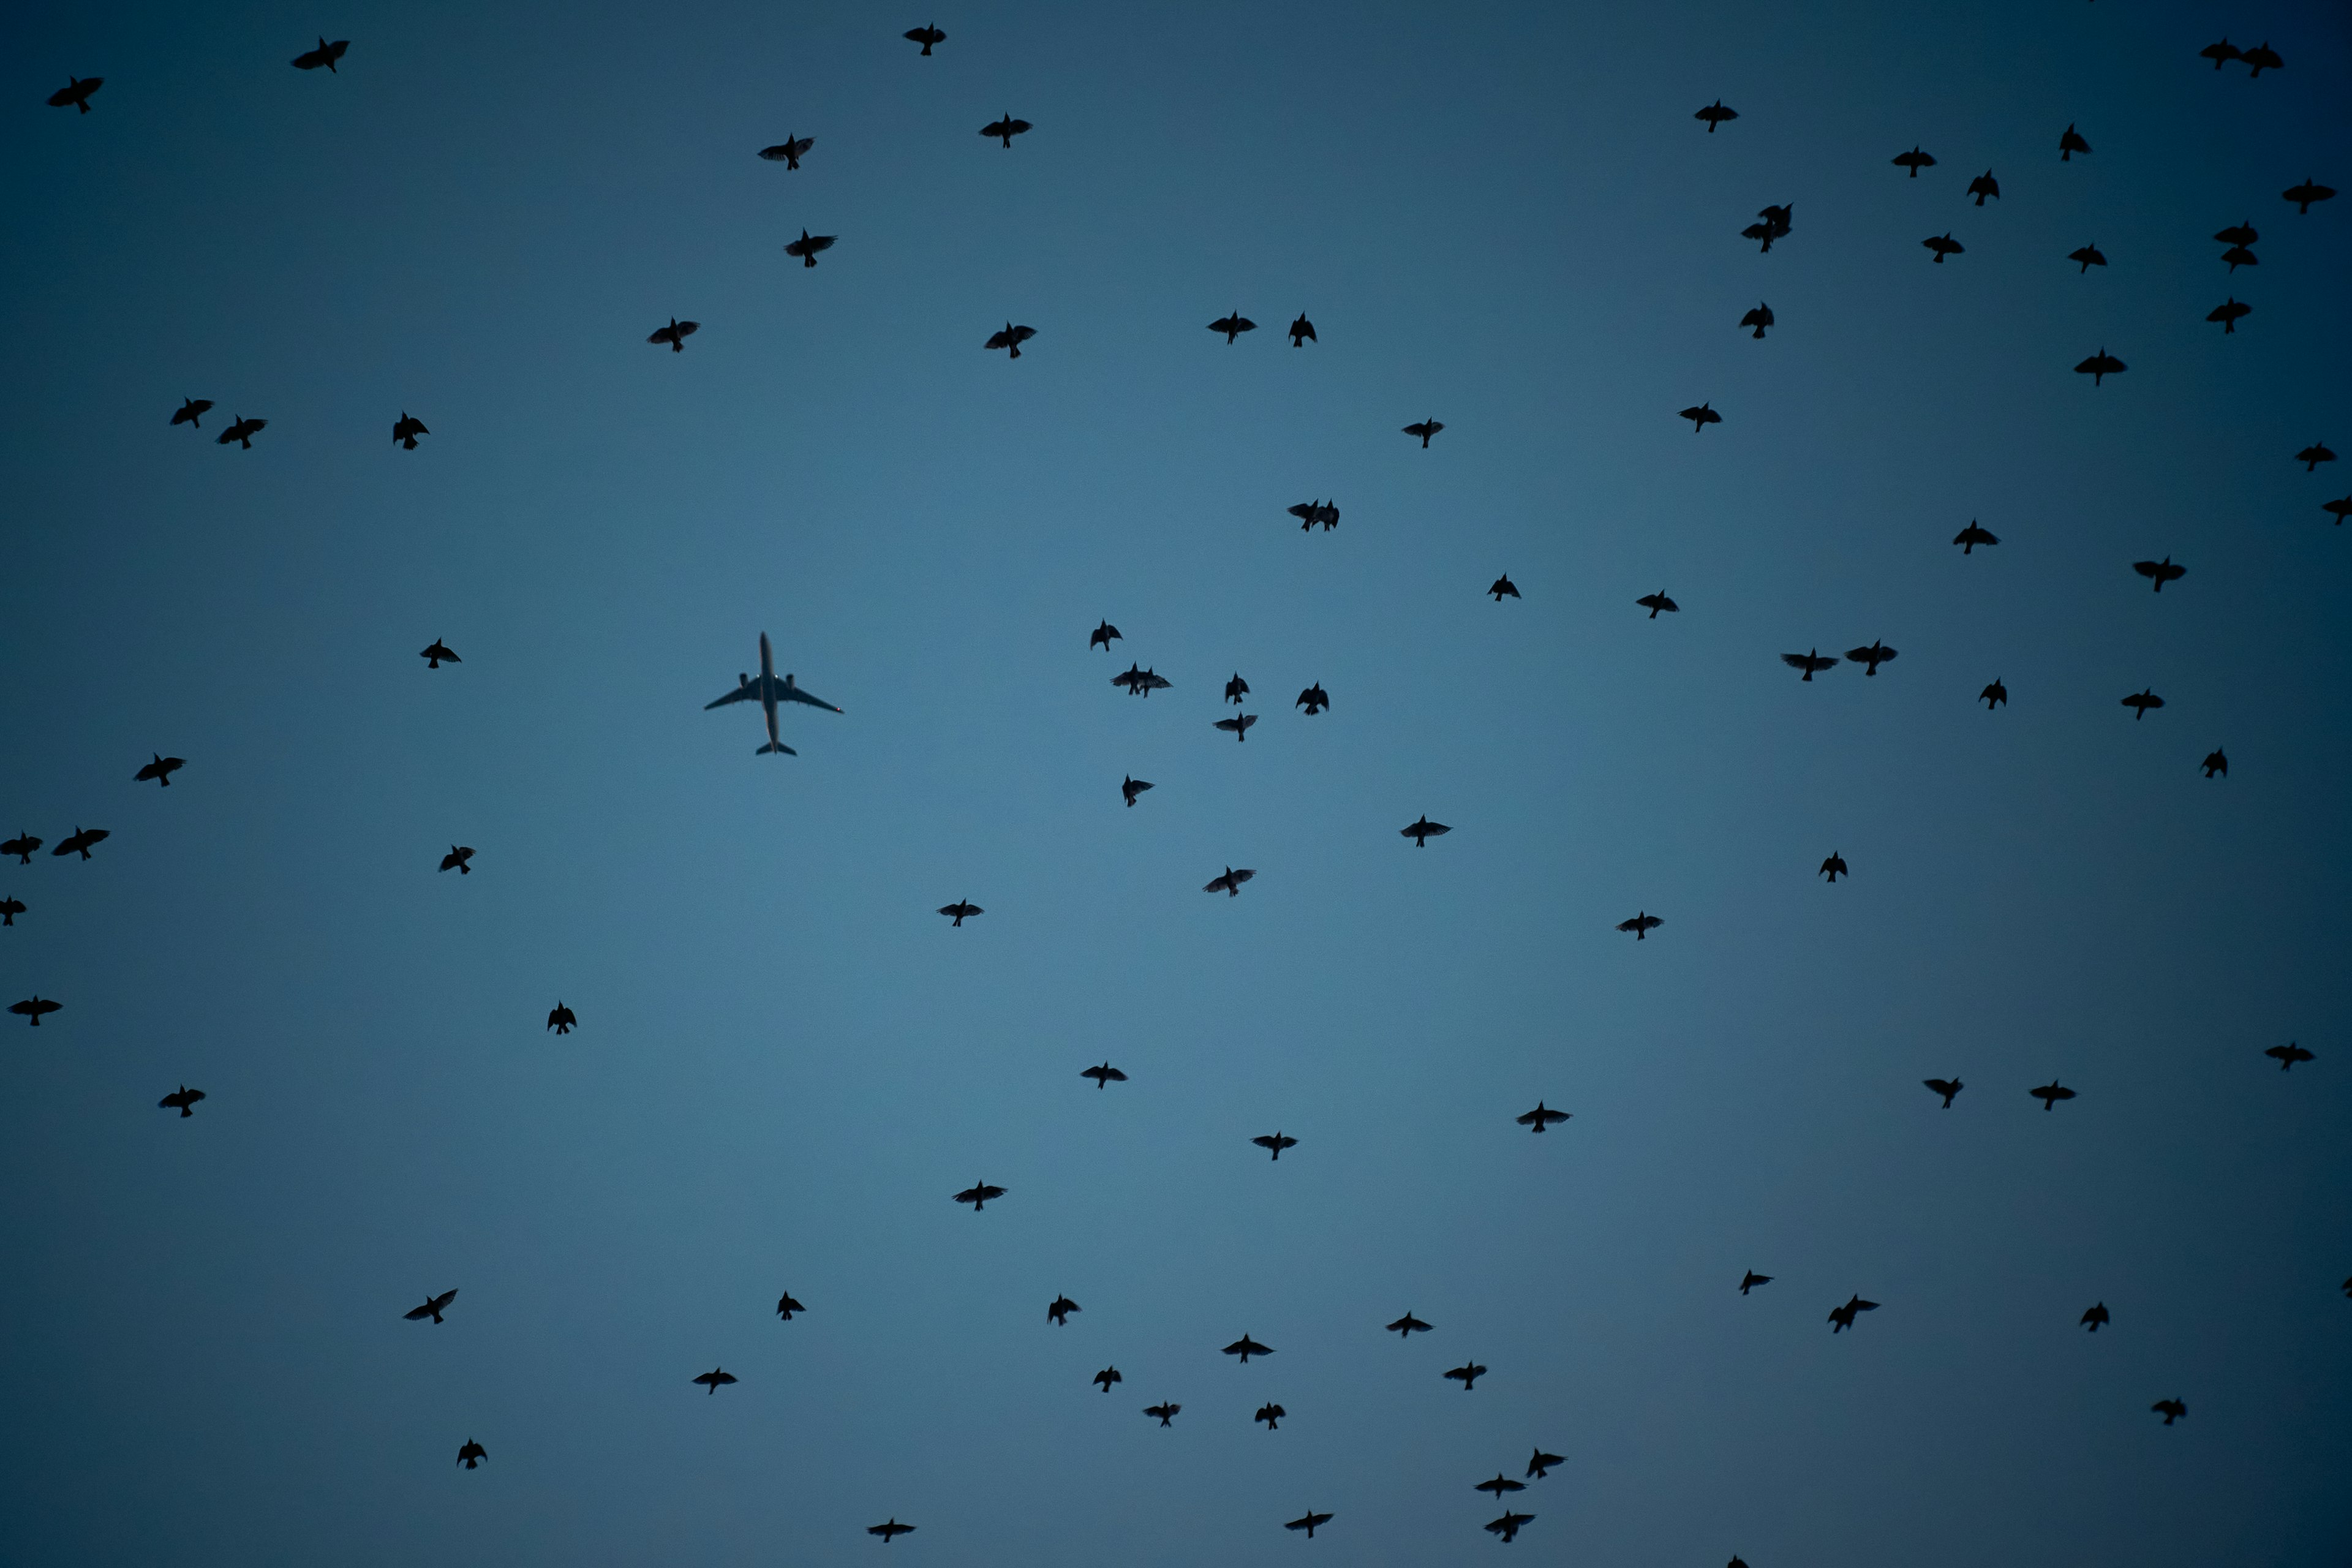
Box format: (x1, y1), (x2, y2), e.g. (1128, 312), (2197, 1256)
(23, 9), (2352, 1568)
